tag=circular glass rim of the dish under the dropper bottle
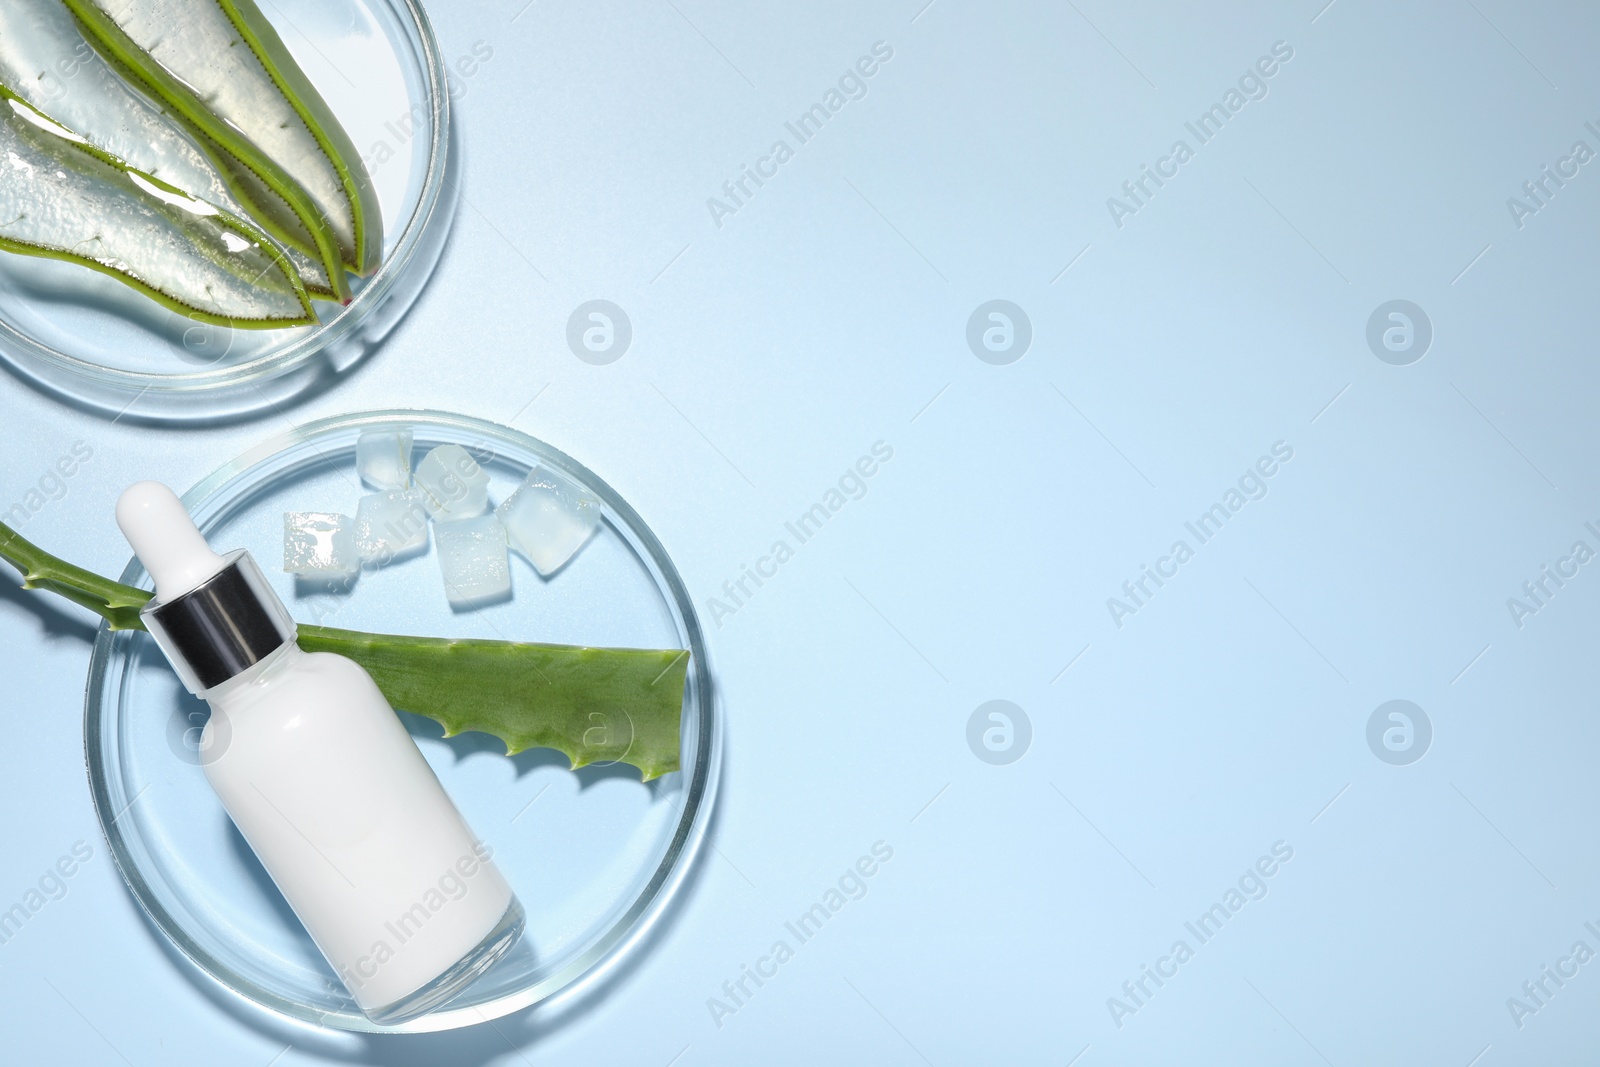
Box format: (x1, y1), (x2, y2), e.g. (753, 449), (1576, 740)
(83, 410), (722, 1033)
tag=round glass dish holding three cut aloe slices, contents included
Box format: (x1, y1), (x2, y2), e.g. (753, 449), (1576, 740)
(0, 0), (457, 422)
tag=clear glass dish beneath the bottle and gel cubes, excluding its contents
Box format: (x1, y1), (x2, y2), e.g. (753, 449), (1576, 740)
(85, 411), (720, 1032)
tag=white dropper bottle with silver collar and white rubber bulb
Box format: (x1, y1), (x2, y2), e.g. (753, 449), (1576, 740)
(117, 482), (523, 1024)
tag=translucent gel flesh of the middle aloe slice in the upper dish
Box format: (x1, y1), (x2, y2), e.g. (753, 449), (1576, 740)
(0, 0), (334, 298)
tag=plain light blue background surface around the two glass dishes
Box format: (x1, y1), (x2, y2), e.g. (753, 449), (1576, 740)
(0, 0), (1600, 1067)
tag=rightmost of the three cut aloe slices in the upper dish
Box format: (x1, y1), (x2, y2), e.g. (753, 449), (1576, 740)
(66, 0), (382, 274)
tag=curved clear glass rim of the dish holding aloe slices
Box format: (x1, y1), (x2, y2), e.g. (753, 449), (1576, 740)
(0, 0), (451, 422)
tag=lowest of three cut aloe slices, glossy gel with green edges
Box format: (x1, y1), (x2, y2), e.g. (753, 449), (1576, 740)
(0, 85), (315, 330)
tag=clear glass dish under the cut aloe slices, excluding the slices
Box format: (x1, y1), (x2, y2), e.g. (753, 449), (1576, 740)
(0, 0), (454, 422)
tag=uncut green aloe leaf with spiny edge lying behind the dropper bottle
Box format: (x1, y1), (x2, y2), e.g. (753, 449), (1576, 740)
(0, 523), (690, 782)
